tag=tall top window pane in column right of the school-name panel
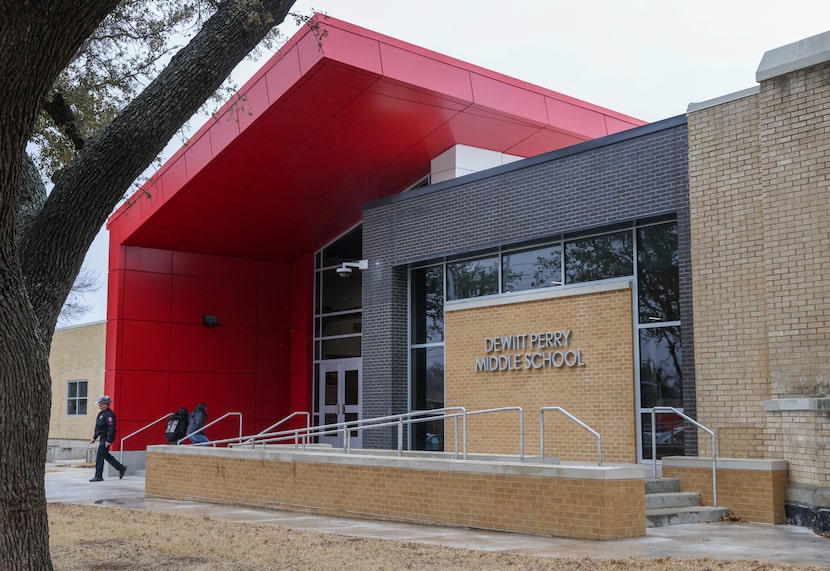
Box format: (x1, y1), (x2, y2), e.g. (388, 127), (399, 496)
(637, 222), (680, 323)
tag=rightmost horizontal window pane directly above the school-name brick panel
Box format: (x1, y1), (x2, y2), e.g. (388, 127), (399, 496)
(565, 231), (634, 284)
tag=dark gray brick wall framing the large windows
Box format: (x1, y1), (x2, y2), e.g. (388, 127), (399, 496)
(363, 117), (694, 448)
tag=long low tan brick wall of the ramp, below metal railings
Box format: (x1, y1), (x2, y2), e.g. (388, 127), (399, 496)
(145, 450), (645, 539)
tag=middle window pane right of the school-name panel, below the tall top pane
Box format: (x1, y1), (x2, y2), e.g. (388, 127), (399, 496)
(640, 327), (683, 408)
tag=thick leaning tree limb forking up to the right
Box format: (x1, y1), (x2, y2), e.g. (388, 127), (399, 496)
(21, 0), (294, 338)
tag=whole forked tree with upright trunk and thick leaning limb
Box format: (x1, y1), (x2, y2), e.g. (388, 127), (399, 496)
(0, 0), (294, 571)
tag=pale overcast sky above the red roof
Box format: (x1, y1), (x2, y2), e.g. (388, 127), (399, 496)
(60, 0), (830, 327)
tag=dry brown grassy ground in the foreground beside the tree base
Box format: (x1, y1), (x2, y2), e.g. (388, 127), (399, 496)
(48, 503), (827, 571)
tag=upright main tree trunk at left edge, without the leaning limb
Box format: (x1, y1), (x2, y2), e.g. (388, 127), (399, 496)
(0, 6), (117, 570)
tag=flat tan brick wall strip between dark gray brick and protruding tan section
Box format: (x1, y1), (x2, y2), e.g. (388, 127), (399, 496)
(688, 97), (770, 458)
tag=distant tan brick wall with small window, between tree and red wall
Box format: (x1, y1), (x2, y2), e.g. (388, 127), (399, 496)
(49, 323), (105, 440)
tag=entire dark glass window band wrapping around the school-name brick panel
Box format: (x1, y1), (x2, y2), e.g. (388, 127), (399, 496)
(409, 217), (685, 459)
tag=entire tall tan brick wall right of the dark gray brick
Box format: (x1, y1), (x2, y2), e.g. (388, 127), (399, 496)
(688, 60), (830, 485)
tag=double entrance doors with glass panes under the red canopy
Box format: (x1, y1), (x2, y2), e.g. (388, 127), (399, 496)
(318, 357), (363, 448)
